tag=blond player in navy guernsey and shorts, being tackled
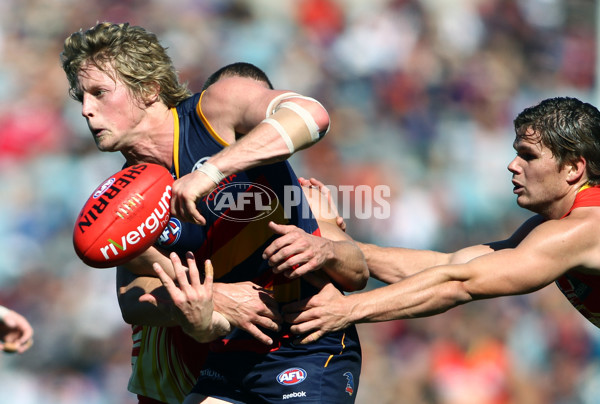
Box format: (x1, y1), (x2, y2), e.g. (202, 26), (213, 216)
(61, 23), (366, 403)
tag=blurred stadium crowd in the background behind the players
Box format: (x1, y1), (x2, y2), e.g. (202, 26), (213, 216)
(0, 0), (600, 404)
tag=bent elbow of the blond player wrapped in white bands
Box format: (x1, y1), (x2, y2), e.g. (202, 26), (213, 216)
(262, 93), (329, 154)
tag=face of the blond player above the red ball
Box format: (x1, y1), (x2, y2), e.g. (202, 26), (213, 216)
(78, 65), (144, 151)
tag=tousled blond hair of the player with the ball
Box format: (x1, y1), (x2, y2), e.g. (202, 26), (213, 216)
(60, 22), (191, 108)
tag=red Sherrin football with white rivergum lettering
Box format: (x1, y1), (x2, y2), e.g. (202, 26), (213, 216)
(73, 164), (173, 268)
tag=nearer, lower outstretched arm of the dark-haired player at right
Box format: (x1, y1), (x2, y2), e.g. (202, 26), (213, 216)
(284, 214), (580, 342)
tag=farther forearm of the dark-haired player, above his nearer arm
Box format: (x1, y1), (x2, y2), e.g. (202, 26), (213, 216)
(356, 242), (450, 284)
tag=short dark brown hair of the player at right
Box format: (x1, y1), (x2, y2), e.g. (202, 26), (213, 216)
(514, 97), (600, 185)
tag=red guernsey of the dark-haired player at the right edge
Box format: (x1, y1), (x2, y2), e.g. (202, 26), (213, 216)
(556, 186), (600, 327)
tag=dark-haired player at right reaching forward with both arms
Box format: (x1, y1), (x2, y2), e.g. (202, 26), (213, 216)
(288, 97), (600, 348)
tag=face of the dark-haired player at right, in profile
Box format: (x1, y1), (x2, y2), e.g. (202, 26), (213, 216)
(508, 129), (570, 217)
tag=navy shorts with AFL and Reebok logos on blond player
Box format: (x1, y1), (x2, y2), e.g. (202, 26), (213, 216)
(192, 326), (361, 404)
